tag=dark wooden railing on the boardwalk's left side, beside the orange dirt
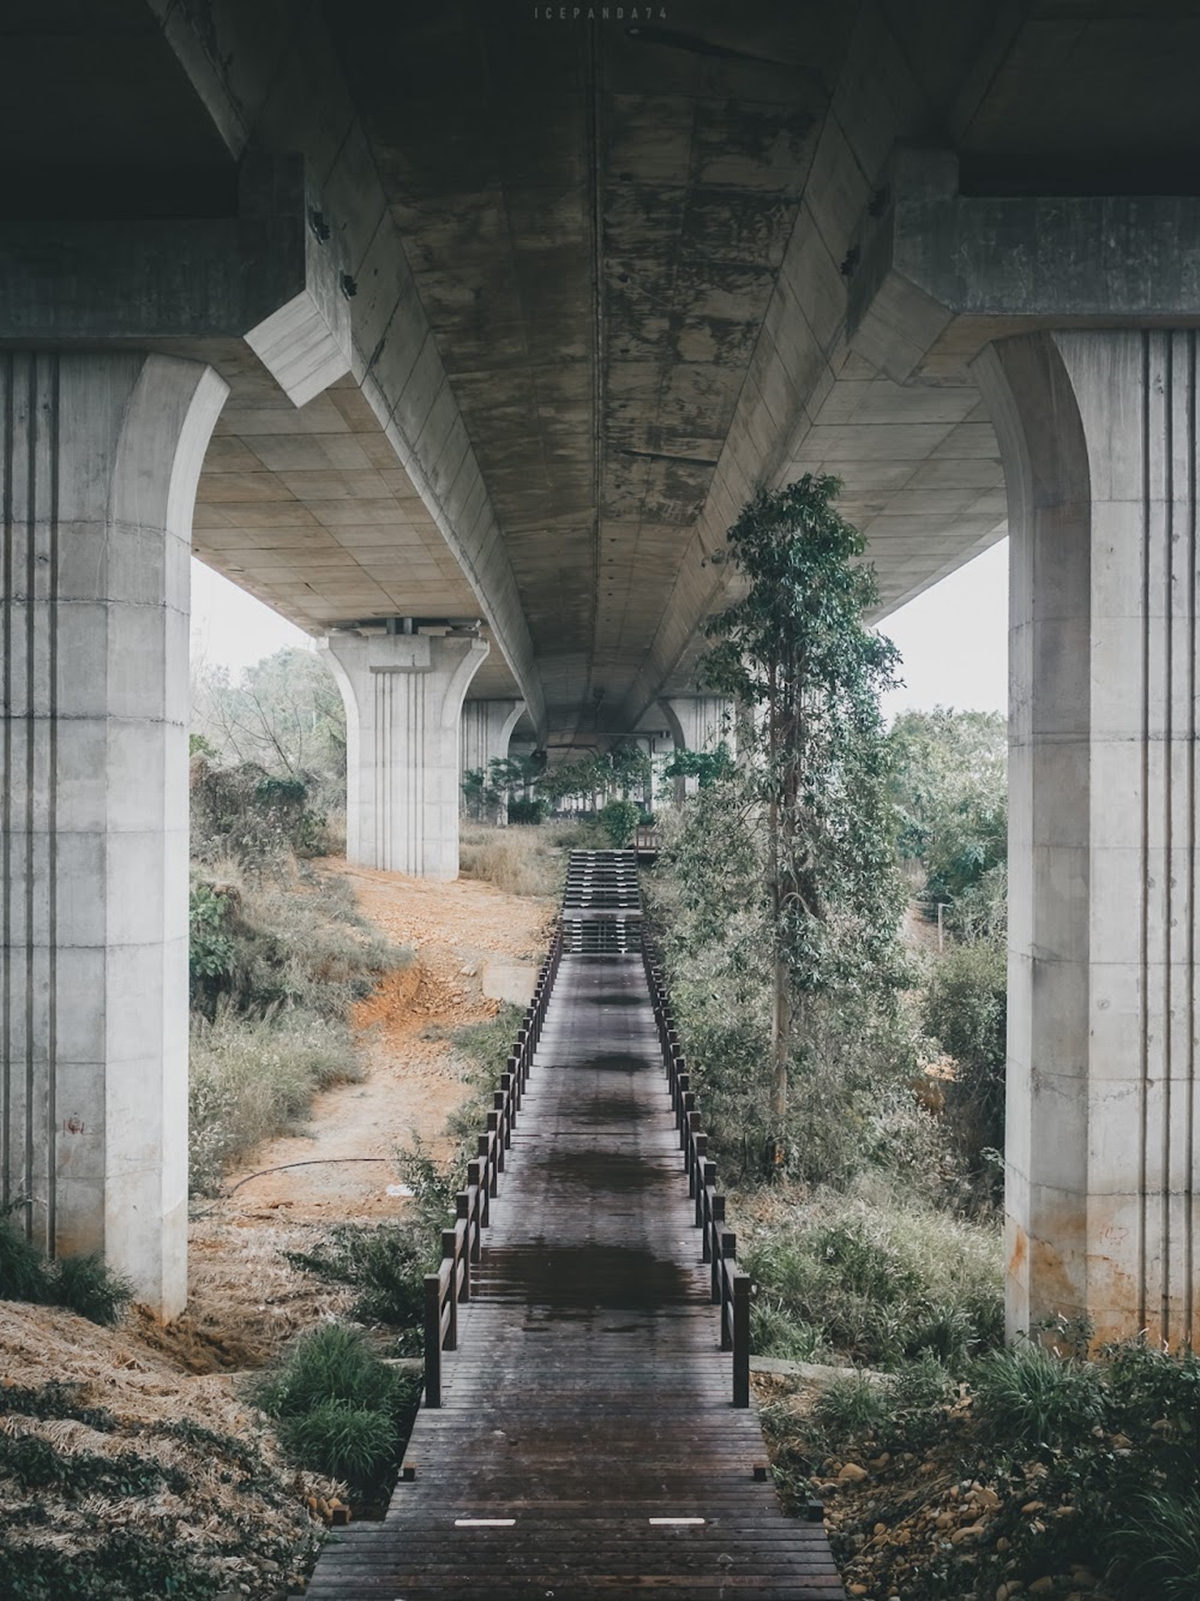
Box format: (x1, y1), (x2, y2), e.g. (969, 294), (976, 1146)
(426, 929), (563, 1406)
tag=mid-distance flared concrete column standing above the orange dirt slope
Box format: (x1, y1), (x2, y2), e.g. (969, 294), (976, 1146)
(325, 634), (488, 879)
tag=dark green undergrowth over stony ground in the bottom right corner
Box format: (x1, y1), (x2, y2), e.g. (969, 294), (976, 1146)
(763, 1330), (1200, 1601)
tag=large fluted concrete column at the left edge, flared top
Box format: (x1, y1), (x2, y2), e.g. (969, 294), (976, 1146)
(0, 352), (227, 1318)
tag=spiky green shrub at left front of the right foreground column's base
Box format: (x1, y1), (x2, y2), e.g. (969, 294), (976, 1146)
(971, 1340), (1104, 1451)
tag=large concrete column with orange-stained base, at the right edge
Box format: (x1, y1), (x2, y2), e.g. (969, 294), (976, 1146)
(974, 330), (1200, 1345)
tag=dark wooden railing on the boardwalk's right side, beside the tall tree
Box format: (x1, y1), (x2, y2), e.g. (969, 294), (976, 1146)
(642, 941), (750, 1406)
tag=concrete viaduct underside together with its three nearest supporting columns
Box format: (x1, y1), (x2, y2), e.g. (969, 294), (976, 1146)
(0, 0), (1200, 1342)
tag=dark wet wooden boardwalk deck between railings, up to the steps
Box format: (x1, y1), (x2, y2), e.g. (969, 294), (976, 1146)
(307, 934), (843, 1601)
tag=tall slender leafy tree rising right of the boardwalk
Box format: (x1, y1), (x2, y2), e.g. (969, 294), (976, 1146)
(704, 474), (899, 1166)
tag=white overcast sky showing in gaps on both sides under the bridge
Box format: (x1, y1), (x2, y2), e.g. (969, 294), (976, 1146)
(192, 540), (1008, 720)
